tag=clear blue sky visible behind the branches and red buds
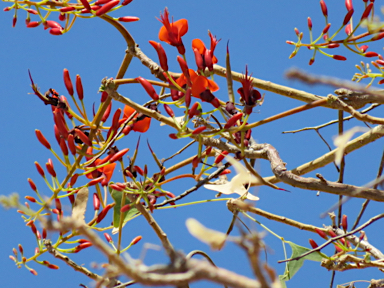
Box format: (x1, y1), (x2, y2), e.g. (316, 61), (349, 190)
(0, 0), (383, 287)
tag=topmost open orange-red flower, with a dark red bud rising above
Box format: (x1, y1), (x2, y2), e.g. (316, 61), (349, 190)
(159, 8), (188, 55)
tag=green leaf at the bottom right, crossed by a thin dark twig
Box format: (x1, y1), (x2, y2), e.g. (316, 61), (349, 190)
(279, 241), (328, 287)
